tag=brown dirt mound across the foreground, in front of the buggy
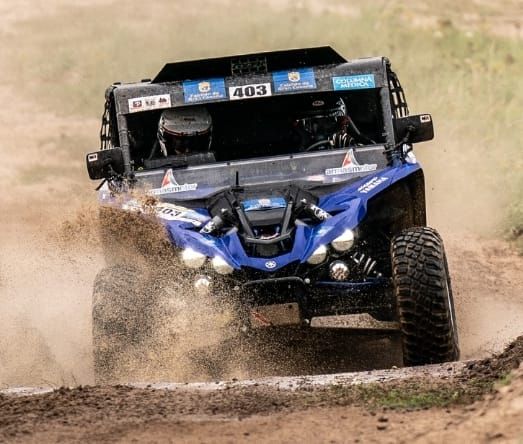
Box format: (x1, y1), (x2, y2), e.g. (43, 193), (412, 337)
(0, 337), (523, 442)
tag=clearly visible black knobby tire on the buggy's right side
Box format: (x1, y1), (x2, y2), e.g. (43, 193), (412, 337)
(391, 227), (459, 365)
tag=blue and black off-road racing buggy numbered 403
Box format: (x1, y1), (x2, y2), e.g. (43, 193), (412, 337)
(86, 47), (459, 379)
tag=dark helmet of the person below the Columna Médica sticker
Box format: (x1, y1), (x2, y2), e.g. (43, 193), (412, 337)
(295, 97), (347, 143)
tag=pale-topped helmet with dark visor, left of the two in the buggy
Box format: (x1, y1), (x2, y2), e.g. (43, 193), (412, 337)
(158, 106), (212, 156)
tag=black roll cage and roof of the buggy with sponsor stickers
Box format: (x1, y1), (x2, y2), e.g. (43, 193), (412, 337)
(100, 47), (409, 175)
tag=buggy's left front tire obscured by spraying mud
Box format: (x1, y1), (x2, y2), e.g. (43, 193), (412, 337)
(92, 266), (154, 384)
